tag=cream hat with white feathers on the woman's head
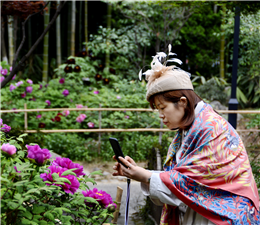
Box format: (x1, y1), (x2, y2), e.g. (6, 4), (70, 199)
(139, 45), (193, 101)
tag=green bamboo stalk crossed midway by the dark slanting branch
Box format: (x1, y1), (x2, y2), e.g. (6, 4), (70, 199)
(42, 5), (50, 83)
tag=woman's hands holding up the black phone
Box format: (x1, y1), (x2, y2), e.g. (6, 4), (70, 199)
(113, 156), (152, 184)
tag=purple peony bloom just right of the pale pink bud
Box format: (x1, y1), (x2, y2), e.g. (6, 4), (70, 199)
(26, 145), (51, 165)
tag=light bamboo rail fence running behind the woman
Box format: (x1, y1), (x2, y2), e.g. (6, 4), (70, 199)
(0, 104), (260, 133)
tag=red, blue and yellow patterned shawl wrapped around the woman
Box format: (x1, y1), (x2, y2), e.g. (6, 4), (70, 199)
(160, 104), (260, 225)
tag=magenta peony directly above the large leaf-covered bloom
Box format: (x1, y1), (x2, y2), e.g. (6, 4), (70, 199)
(52, 157), (86, 177)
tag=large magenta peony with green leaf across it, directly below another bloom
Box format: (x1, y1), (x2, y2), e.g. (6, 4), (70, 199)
(40, 165), (80, 194)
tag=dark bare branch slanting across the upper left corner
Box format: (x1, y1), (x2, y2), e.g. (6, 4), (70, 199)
(0, 0), (67, 89)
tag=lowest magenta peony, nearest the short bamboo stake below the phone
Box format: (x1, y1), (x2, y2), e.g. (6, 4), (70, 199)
(82, 188), (116, 208)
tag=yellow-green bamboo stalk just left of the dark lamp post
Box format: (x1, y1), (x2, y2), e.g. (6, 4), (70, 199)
(220, 6), (226, 79)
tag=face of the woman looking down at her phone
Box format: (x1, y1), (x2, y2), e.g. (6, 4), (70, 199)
(154, 96), (187, 130)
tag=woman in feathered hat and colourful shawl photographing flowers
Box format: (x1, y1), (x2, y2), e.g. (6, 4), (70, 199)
(113, 46), (260, 225)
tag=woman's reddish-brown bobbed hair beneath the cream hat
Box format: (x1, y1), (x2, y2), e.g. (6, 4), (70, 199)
(149, 90), (202, 130)
